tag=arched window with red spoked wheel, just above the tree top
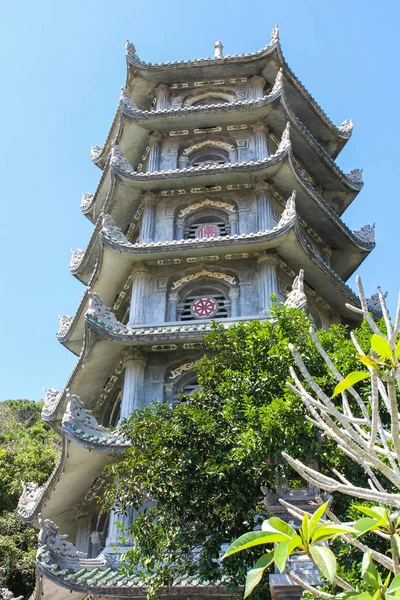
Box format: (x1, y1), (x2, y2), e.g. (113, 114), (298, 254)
(176, 281), (231, 321)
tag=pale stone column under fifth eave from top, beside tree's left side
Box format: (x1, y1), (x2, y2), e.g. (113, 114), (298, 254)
(119, 348), (146, 422)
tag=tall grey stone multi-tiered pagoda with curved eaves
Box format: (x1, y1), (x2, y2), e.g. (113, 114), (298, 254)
(19, 28), (374, 600)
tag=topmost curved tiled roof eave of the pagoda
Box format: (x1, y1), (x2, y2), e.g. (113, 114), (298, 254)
(127, 41), (351, 157)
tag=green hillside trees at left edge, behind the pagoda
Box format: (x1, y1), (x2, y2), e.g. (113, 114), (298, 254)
(0, 400), (59, 597)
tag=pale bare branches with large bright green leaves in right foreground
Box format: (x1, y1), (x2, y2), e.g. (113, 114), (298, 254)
(225, 278), (400, 600)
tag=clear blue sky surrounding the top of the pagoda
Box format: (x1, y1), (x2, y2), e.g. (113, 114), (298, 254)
(0, 0), (400, 399)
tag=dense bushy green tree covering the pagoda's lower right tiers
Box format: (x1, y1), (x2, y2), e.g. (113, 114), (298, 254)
(103, 306), (368, 594)
